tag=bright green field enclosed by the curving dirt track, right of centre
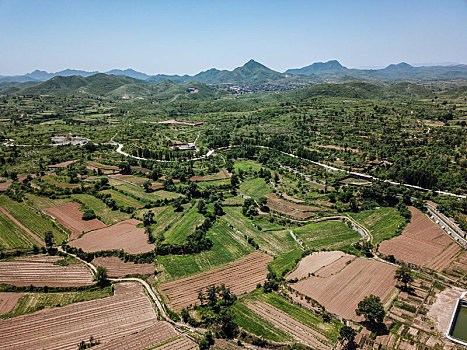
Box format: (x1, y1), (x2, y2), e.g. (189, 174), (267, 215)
(293, 221), (361, 250)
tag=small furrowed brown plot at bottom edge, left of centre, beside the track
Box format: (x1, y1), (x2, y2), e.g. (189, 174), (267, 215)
(93, 321), (178, 350)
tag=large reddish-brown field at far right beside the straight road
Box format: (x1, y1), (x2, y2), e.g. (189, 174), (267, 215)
(379, 207), (459, 271)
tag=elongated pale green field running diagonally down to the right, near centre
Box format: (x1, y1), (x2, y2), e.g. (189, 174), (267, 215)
(223, 207), (299, 255)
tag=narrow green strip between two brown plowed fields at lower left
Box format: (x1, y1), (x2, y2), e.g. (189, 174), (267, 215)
(0, 287), (112, 318)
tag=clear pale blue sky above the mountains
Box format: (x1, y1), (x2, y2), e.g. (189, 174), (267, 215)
(0, 0), (467, 75)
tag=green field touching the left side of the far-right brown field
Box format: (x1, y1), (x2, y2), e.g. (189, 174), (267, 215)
(349, 207), (405, 244)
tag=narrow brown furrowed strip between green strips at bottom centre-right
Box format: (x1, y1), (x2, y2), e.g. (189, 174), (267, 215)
(247, 301), (330, 349)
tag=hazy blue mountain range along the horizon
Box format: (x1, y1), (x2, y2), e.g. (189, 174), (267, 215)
(0, 60), (467, 86)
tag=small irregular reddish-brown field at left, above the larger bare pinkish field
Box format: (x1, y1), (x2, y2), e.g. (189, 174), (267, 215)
(44, 203), (105, 240)
